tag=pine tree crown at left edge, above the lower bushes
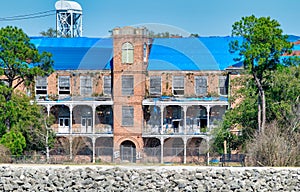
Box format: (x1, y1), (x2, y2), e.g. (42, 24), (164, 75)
(0, 26), (53, 101)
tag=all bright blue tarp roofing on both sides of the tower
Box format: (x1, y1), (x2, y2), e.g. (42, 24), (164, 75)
(31, 36), (300, 71)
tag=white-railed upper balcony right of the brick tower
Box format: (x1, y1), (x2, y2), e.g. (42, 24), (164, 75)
(143, 97), (228, 136)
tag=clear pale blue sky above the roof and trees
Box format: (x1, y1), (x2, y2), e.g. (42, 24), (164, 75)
(0, 0), (300, 37)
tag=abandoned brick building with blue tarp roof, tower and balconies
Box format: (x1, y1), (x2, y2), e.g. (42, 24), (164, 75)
(31, 27), (246, 163)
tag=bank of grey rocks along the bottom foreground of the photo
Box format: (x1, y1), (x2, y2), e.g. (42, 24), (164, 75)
(0, 165), (300, 192)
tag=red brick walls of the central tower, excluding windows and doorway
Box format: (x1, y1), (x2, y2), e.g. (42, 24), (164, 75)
(113, 27), (149, 151)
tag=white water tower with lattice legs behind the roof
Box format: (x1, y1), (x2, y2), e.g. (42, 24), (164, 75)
(55, 0), (82, 37)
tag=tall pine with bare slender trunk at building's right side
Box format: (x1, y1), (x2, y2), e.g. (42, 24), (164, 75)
(231, 15), (292, 132)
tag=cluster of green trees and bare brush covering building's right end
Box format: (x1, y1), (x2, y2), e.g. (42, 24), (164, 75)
(213, 16), (300, 162)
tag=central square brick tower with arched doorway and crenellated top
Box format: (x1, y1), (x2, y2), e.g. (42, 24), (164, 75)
(112, 27), (150, 162)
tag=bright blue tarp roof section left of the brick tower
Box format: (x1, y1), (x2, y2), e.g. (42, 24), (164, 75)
(31, 37), (113, 70)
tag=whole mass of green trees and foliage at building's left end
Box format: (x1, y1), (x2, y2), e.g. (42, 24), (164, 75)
(0, 26), (53, 155)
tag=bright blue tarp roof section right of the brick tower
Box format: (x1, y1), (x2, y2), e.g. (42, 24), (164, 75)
(148, 37), (242, 71)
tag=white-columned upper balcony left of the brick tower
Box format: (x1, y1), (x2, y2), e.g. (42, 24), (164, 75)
(36, 96), (113, 137)
